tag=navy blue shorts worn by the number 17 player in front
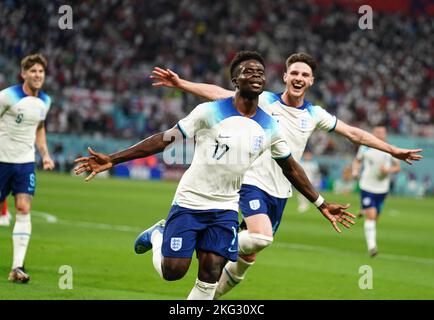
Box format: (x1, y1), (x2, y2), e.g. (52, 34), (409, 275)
(161, 205), (238, 261)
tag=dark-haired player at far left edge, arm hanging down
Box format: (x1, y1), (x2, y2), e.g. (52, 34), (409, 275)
(0, 54), (54, 283)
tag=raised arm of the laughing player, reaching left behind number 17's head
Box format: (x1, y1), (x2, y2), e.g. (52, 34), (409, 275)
(150, 67), (235, 100)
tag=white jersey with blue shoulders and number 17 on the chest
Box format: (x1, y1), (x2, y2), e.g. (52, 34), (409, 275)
(173, 98), (291, 211)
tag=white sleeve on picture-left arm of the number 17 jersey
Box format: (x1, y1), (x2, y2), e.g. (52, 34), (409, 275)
(177, 102), (211, 138)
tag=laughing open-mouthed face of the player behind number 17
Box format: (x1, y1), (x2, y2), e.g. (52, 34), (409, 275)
(283, 62), (314, 99)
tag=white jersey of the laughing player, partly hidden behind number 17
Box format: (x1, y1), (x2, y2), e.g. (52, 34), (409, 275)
(243, 91), (337, 198)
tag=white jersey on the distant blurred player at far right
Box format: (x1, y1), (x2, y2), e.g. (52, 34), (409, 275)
(356, 146), (395, 193)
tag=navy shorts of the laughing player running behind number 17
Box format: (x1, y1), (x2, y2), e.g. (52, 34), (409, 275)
(239, 184), (288, 235)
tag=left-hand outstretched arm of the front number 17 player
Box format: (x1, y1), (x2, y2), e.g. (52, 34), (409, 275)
(74, 127), (182, 181)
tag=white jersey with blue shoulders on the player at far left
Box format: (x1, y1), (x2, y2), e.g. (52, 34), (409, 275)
(0, 85), (51, 163)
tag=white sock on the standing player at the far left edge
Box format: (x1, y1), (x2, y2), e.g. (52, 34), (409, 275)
(12, 213), (32, 269)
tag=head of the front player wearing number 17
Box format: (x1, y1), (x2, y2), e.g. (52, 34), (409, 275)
(232, 59), (265, 99)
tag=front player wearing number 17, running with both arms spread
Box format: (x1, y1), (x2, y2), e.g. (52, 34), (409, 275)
(75, 52), (354, 299)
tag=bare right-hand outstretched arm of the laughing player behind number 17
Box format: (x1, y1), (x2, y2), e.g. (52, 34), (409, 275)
(335, 120), (422, 164)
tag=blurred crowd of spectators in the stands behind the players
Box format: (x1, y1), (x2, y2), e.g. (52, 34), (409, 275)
(0, 0), (434, 154)
